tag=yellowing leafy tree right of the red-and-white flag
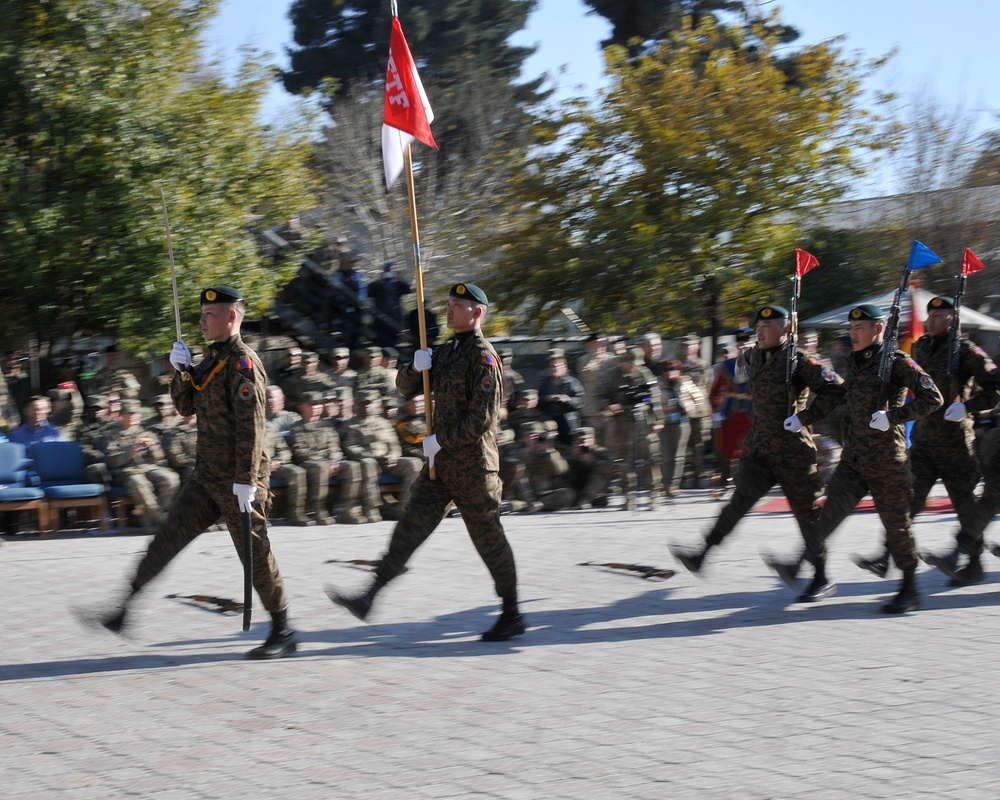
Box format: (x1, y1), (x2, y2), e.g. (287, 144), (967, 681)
(486, 15), (891, 332)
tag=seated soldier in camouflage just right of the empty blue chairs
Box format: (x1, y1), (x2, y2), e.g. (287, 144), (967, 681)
(101, 400), (181, 533)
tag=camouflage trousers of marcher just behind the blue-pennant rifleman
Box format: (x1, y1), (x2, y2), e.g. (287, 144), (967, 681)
(910, 438), (986, 554)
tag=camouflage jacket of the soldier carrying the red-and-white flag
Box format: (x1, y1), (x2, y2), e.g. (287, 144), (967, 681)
(396, 330), (503, 472)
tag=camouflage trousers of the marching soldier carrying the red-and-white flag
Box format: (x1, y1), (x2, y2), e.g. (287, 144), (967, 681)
(375, 464), (517, 599)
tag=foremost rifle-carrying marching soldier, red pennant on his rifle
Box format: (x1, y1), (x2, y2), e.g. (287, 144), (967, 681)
(671, 305), (844, 573)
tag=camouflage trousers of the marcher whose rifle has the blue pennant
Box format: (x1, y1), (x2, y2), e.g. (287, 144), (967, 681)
(803, 453), (917, 572)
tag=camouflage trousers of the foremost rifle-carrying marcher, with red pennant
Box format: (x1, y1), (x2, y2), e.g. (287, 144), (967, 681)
(705, 448), (823, 547)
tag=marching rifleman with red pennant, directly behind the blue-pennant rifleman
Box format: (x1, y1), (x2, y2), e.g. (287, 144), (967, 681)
(855, 297), (1000, 586)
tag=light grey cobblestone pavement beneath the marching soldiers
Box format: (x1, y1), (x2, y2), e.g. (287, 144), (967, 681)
(0, 484), (1000, 800)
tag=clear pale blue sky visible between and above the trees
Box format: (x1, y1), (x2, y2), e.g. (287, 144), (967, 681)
(207, 0), (1000, 193)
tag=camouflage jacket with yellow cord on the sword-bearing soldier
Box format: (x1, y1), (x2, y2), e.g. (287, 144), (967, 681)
(170, 334), (271, 487)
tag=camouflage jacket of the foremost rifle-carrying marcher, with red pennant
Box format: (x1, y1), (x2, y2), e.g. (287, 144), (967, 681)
(740, 343), (844, 453)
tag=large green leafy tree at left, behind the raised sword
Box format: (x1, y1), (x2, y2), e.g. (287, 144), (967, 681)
(0, 0), (313, 352)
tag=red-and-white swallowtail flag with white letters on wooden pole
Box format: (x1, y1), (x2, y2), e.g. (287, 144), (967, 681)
(382, 17), (437, 187)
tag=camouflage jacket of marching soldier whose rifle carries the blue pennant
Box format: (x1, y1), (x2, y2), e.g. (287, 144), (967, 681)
(842, 343), (942, 461)
